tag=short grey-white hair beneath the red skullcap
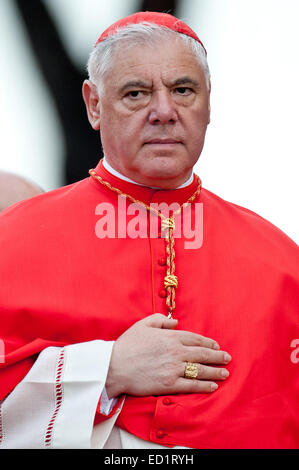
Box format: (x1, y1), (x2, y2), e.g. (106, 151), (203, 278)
(87, 22), (210, 95)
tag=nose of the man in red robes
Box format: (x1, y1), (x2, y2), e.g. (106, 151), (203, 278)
(149, 90), (178, 125)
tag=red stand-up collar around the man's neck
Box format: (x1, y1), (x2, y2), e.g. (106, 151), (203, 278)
(90, 160), (202, 205)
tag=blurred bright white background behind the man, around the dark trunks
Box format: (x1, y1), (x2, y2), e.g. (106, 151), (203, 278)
(0, 0), (299, 243)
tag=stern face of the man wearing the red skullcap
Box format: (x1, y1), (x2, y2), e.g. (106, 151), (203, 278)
(84, 39), (210, 189)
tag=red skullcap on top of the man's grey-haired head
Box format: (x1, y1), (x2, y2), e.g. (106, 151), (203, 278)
(95, 11), (207, 53)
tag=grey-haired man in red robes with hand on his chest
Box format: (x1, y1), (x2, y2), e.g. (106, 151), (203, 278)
(0, 13), (299, 448)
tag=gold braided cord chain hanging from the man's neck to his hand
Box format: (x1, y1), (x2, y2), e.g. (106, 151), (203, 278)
(89, 170), (201, 318)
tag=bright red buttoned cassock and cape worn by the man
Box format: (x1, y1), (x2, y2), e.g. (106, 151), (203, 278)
(0, 163), (299, 449)
